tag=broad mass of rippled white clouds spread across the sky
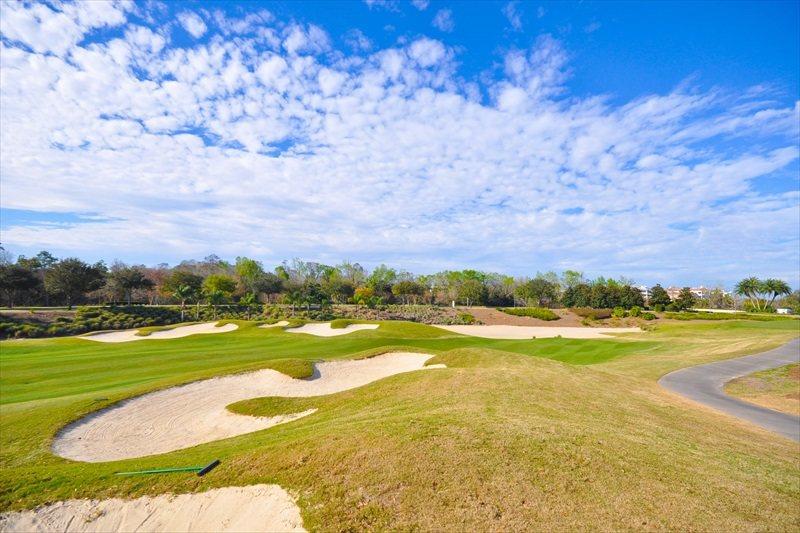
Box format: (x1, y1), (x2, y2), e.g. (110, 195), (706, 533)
(0, 4), (800, 283)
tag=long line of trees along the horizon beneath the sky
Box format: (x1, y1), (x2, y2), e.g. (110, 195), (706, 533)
(0, 251), (791, 310)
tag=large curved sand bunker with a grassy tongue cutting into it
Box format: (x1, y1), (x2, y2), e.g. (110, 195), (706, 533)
(53, 352), (444, 462)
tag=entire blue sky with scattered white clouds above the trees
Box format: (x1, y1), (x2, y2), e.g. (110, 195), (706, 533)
(0, 0), (800, 287)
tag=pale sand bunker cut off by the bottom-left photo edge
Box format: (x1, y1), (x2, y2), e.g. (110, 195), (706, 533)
(0, 485), (305, 532)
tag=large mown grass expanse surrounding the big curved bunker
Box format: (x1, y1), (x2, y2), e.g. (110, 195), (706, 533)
(0, 321), (800, 530)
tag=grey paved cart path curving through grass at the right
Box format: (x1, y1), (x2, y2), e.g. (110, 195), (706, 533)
(658, 339), (800, 441)
